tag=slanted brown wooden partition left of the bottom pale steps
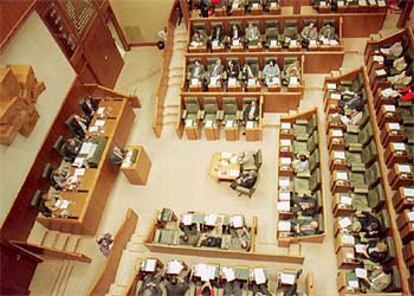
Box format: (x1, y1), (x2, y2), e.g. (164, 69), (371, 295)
(89, 209), (138, 295)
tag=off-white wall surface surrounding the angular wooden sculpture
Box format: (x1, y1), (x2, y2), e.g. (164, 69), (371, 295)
(0, 13), (76, 225)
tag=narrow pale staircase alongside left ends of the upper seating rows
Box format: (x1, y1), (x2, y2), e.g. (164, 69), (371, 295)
(162, 25), (187, 127)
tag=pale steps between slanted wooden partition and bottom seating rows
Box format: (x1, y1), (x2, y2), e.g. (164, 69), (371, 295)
(106, 233), (145, 296)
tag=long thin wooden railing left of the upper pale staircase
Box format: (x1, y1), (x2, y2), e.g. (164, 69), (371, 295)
(152, 0), (180, 138)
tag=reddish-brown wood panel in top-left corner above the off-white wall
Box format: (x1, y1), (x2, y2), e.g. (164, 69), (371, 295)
(0, 0), (38, 49)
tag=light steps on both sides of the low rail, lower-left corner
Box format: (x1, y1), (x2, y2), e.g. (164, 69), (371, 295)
(28, 227), (80, 296)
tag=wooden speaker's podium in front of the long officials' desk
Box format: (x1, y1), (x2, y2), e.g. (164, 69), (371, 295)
(121, 146), (151, 185)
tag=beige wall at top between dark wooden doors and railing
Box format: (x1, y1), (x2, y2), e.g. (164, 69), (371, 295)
(110, 0), (174, 42)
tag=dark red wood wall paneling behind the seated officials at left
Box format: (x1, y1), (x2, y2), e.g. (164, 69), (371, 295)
(0, 79), (86, 241)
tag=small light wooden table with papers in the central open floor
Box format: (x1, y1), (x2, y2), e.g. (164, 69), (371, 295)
(208, 152), (240, 181)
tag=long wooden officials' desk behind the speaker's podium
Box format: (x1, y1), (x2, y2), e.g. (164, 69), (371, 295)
(37, 99), (135, 235)
